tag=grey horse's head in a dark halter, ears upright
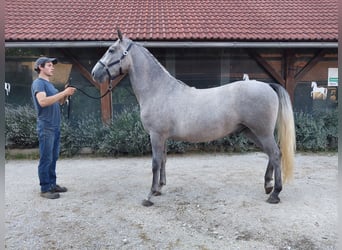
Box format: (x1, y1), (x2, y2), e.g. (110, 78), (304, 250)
(91, 30), (133, 83)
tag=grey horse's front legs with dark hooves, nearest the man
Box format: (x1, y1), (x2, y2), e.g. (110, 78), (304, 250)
(143, 134), (166, 206)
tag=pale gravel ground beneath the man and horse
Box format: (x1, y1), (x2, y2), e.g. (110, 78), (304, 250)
(5, 153), (338, 250)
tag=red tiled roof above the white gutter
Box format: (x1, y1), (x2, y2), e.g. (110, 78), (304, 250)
(5, 0), (338, 42)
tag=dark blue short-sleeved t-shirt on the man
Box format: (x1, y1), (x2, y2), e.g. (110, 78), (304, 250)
(31, 78), (61, 129)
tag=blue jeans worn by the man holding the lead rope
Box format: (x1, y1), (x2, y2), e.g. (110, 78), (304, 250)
(38, 126), (60, 192)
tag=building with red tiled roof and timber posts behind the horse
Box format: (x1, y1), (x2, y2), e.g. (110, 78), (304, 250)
(5, 0), (338, 121)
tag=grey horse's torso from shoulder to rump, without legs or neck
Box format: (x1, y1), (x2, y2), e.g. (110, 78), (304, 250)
(145, 81), (278, 142)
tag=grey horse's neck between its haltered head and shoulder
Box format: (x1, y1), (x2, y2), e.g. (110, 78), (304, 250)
(129, 45), (176, 103)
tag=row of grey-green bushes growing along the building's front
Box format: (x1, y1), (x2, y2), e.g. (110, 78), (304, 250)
(5, 105), (338, 156)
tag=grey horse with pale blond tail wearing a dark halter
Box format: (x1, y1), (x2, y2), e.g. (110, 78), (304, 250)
(92, 31), (296, 206)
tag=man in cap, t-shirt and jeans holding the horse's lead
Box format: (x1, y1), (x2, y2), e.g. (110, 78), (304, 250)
(31, 57), (76, 199)
